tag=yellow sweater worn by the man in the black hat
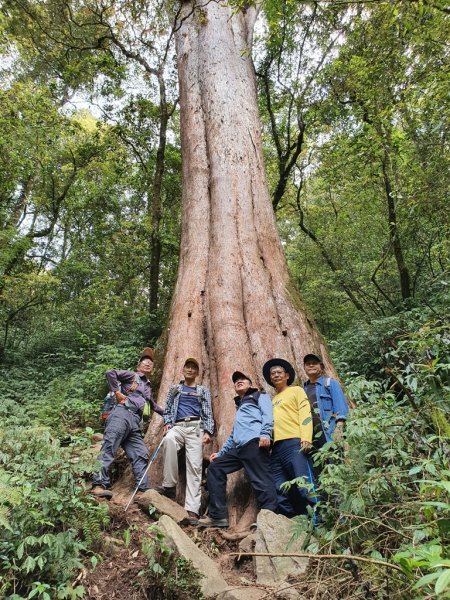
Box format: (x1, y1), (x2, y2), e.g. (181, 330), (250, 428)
(272, 385), (313, 442)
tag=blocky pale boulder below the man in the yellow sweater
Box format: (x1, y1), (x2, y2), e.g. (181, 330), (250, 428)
(255, 510), (309, 586)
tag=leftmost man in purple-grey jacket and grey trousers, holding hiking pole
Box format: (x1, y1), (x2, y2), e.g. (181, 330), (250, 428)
(91, 348), (164, 499)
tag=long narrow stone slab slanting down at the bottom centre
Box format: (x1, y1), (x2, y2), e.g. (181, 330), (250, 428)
(157, 512), (229, 598)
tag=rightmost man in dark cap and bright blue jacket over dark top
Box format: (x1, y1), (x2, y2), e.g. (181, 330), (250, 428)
(303, 353), (348, 451)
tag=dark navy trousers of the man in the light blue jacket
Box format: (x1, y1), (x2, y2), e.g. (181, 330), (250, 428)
(208, 438), (277, 519)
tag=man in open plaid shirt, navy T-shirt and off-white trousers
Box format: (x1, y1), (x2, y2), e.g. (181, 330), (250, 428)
(163, 358), (214, 525)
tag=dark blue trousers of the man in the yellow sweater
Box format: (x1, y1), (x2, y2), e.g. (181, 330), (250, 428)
(271, 438), (318, 518)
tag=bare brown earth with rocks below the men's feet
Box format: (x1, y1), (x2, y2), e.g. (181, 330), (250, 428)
(78, 490), (316, 600)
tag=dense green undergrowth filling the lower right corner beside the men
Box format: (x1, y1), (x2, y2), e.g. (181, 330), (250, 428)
(299, 319), (450, 599)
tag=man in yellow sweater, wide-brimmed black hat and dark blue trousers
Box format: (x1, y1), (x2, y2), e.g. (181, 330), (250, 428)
(263, 358), (318, 518)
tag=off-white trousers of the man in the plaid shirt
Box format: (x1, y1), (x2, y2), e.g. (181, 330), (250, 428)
(163, 421), (203, 514)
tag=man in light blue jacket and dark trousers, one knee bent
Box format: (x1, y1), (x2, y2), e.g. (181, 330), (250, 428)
(198, 371), (277, 527)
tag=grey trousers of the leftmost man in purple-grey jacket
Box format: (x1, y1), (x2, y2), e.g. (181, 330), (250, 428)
(94, 404), (150, 490)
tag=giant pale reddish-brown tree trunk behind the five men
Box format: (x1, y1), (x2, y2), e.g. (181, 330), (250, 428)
(142, 2), (332, 521)
